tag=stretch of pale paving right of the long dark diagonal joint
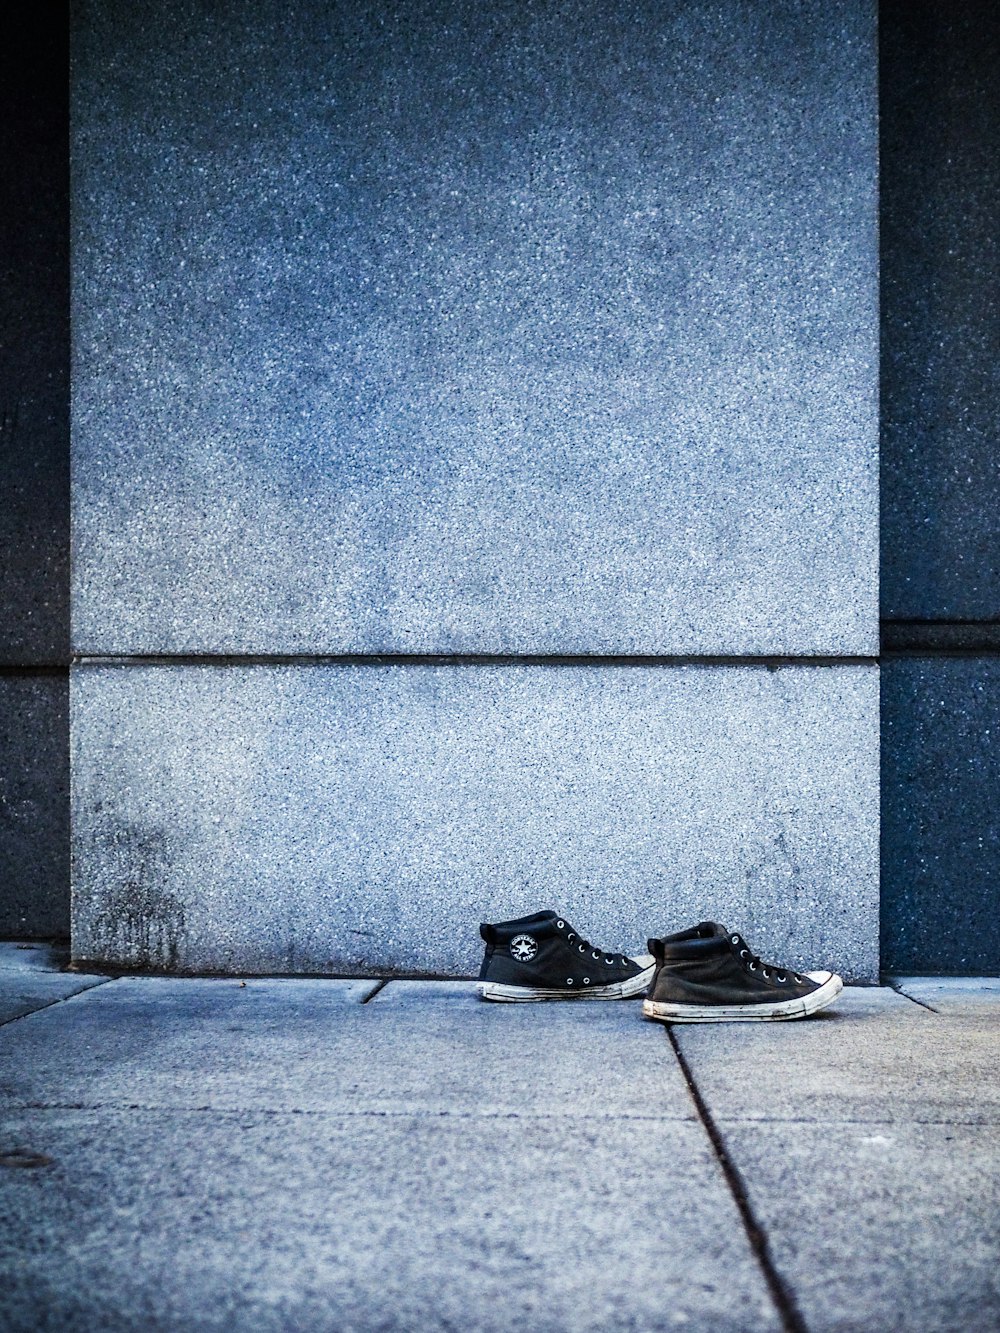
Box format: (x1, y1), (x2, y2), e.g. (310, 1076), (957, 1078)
(661, 978), (1000, 1333)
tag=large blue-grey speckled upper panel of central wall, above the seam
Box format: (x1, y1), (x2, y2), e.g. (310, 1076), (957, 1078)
(73, 0), (877, 655)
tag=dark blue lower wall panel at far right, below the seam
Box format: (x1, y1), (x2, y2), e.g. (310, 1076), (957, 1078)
(881, 657), (1000, 974)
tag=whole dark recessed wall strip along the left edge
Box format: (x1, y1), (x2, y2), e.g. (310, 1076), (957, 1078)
(0, 11), (69, 937)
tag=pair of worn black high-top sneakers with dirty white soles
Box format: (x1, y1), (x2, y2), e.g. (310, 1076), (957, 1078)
(479, 912), (844, 1022)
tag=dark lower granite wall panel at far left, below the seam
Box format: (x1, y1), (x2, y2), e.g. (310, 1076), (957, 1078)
(0, 670), (69, 938)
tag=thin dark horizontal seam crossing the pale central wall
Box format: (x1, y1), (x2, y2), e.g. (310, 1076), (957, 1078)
(72, 653), (879, 670)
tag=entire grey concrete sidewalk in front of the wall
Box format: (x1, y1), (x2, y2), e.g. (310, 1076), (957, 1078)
(0, 944), (1000, 1333)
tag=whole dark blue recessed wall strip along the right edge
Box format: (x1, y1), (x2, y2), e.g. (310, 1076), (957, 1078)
(881, 0), (1000, 973)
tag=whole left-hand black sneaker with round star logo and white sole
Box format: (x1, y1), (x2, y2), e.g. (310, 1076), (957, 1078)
(479, 912), (653, 1000)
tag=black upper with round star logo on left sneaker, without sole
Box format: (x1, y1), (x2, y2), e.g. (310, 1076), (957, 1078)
(479, 912), (643, 989)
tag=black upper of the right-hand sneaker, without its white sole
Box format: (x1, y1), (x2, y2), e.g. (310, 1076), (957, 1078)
(648, 921), (819, 1005)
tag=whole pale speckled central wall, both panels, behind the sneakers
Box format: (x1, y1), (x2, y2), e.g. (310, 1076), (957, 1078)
(73, 0), (877, 978)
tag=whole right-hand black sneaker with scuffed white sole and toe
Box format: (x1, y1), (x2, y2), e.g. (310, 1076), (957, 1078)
(643, 921), (844, 1022)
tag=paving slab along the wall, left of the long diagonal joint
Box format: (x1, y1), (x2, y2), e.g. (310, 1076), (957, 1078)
(0, 977), (693, 1121)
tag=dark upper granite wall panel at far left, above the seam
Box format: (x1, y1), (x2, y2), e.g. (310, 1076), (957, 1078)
(0, 7), (69, 661)
